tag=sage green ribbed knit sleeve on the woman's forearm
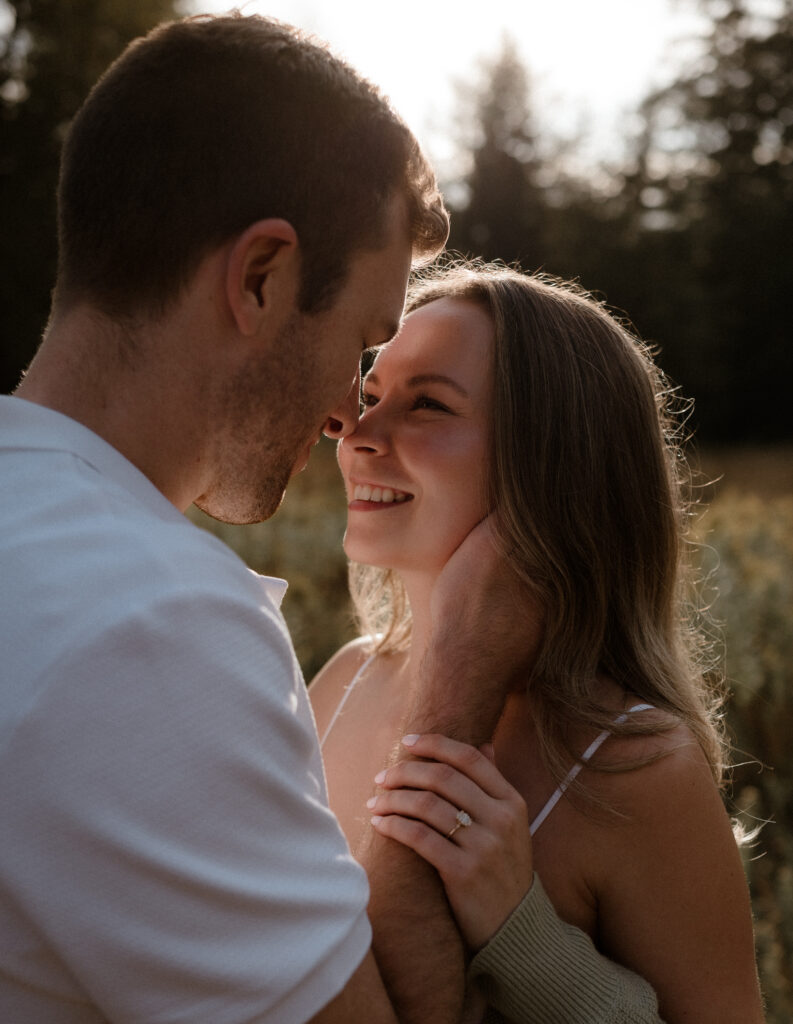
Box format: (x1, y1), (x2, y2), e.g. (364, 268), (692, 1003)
(468, 874), (663, 1024)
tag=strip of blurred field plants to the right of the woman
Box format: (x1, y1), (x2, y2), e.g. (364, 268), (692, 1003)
(698, 487), (793, 1024)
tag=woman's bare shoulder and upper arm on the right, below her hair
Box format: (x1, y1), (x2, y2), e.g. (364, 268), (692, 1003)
(586, 713), (760, 1022)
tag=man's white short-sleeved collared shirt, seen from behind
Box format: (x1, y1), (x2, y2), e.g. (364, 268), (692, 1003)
(0, 397), (371, 1024)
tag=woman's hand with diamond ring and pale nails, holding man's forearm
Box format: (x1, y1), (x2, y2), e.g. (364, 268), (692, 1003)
(367, 734), (533, 950)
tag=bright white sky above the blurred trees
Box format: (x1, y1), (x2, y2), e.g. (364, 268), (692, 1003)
(190, 0), (713, 169)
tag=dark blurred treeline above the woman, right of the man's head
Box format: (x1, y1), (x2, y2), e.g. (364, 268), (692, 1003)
(440, 0), (793, 441)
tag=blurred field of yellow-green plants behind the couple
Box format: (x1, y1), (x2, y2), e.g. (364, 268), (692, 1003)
(192, 440), (793, 1024)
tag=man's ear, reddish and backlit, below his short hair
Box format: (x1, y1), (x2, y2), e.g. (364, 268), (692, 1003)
(225, 218), (299, 336)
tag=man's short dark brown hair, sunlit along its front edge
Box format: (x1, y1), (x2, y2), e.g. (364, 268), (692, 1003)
(55, 12), (448, 317)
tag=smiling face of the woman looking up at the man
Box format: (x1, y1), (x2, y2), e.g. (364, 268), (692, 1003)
(338, 298), (494, 572)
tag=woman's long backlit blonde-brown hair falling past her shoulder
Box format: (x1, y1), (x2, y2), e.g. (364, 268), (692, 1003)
(350, 261), (724, 783)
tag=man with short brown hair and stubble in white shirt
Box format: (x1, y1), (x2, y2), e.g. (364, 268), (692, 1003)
(0, 9), (523, 1024)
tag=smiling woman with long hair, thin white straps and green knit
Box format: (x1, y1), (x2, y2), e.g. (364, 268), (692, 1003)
(310, 263), (762, 1024)
